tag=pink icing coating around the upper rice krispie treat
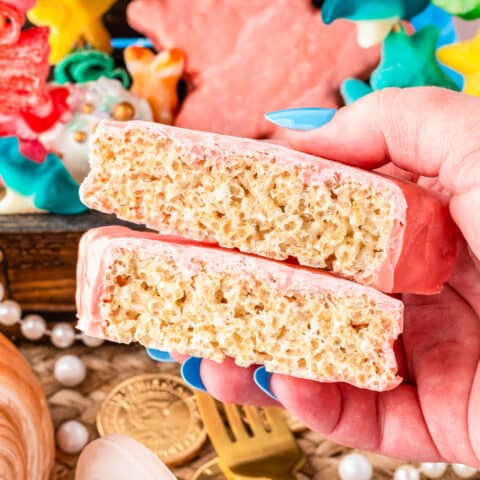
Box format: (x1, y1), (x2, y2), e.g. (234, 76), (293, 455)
(80, 121), (457, 294)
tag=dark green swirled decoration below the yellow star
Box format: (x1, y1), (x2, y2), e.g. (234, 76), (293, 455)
(54, 50), (130, 88)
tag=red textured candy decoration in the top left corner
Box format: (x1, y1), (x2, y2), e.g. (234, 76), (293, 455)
(0, 2), (49, 115)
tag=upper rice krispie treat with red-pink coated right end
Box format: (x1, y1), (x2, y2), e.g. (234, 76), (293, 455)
(81, 121), (457, 294)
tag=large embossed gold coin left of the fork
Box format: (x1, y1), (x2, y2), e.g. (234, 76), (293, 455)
(97, 374), (207, 466)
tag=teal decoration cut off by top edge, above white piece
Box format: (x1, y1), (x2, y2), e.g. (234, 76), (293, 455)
(322, 0), (430, 24)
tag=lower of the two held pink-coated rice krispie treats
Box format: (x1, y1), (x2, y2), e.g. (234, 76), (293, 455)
(77, 227), (403, 391)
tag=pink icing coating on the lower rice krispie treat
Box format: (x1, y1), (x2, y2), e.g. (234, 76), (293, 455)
(77, 226), (403, 388)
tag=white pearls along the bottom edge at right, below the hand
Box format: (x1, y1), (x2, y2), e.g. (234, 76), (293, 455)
(338, 453), (477, 480)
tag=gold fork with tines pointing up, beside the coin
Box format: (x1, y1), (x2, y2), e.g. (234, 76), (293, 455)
(195, 392), (304, 480)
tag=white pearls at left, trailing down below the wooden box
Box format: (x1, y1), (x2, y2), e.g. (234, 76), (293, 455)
(0, 283), (103, 454)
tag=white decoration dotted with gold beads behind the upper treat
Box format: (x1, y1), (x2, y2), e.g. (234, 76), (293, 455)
(38, 77), (152, 183)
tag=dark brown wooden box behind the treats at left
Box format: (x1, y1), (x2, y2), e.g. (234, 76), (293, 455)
(0, 212), (132, 312)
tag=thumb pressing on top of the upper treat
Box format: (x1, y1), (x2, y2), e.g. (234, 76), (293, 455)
(287, 87), (480, 194)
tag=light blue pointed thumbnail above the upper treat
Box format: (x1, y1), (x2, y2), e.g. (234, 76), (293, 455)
(265, 108), (337, 130)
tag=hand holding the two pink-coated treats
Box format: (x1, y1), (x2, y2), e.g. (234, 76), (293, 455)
(151, 88), (480, 467)
